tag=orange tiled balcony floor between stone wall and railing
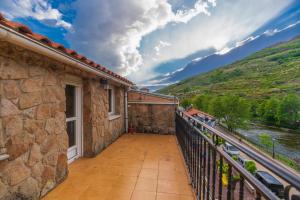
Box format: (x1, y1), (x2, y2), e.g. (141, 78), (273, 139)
(44, 134), (194, 200)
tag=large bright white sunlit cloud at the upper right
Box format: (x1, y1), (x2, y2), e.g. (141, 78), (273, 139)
(130, 0), (292, 82)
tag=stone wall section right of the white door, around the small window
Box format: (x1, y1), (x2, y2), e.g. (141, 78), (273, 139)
(83, 80), (125, 157)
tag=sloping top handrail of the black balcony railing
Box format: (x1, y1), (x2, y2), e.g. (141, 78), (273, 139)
(177, 110), (300, 191)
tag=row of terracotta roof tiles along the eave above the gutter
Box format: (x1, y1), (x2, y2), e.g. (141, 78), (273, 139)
(0, 13), (133, 84)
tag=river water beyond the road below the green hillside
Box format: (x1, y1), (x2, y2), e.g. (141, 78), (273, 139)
(238, 125), (300, 160)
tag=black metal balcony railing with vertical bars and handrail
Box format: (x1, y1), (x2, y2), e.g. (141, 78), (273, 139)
(176, 111), (300, 200)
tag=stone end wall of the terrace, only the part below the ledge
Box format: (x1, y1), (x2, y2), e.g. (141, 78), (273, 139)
(128, 103), (177, 134)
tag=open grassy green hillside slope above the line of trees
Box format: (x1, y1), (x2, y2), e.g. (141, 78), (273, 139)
(158, 37), (300, 99)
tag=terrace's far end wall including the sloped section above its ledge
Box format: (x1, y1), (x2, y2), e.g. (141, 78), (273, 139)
(128, 90), (179, 134)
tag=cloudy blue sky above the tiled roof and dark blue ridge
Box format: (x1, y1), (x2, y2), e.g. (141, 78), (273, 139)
(0, 0), (300, 83)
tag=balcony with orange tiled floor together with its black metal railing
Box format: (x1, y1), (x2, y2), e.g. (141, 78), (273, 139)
(44, 111), (300, 200)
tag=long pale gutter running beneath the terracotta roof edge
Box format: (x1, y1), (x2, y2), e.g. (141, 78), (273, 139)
(0, 25), (132, 87)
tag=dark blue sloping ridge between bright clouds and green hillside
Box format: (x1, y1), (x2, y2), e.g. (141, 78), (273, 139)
(151, 21), (300, 88)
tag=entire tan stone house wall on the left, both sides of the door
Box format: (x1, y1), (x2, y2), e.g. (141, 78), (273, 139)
(0, 41), (124, 200)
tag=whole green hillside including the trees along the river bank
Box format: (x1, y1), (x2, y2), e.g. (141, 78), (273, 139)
(159, 38), (300, 130)
